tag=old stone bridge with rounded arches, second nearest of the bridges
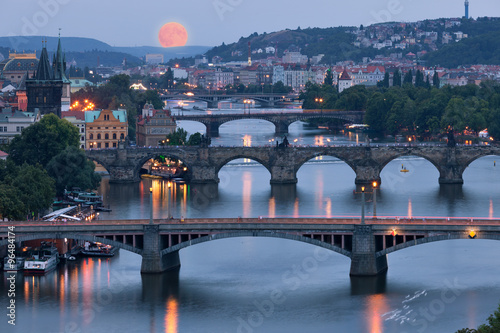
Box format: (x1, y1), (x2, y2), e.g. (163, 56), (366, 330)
(86, 145), (500, 185)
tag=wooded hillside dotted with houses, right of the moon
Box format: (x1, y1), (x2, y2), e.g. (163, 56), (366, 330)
(171, 17), (500, 67)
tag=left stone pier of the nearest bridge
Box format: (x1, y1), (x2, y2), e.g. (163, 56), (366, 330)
(141, 225), (181, 274)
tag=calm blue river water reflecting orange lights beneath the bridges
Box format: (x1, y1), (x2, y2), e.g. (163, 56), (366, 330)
(0, 107), (500, 333)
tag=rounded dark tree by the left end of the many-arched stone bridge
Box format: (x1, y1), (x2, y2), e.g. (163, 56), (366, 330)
(47, 146), (101, 196)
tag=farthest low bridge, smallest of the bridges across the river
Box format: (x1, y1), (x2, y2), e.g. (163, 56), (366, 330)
(160, 94), (295, 108)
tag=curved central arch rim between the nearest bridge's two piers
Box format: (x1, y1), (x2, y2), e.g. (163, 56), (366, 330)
(160, 231), (351, 258)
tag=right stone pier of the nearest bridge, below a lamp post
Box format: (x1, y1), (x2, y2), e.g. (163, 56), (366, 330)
(349, 225), (388, 276)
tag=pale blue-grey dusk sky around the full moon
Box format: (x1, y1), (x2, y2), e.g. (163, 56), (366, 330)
(0, 0), (500, 46)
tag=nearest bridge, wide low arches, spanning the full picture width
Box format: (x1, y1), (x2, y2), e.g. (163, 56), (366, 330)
(0, 218), (500, 276)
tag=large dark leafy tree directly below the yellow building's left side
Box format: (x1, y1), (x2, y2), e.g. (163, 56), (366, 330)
(9, 114), (80, 168)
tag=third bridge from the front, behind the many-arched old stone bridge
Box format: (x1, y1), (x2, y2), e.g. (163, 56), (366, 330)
(174, 110), (365, 137)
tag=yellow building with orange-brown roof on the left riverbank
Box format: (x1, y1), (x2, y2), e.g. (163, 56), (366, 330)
(85, 110), (128, 149)
